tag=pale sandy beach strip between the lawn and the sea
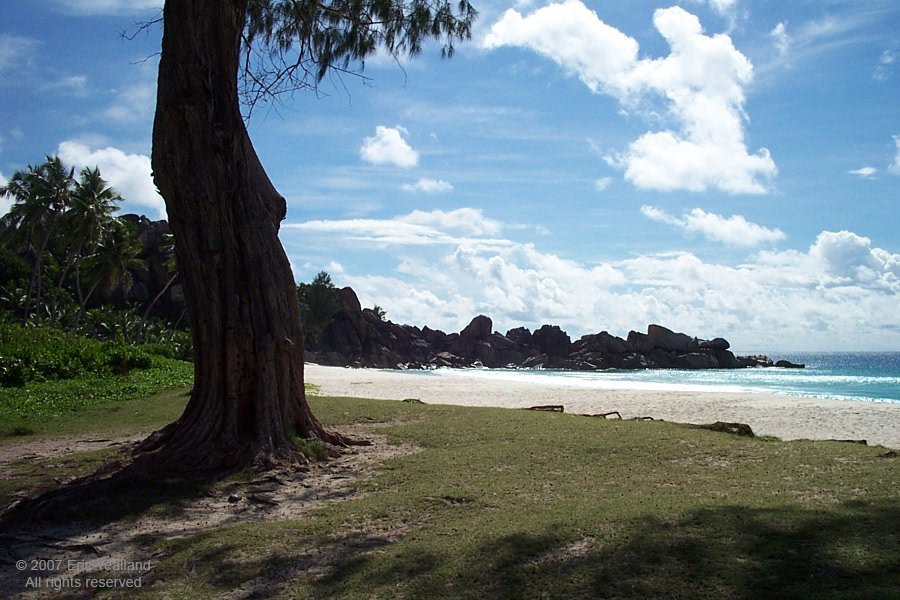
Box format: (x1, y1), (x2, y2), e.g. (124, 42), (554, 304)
(306, 364), (900, 448)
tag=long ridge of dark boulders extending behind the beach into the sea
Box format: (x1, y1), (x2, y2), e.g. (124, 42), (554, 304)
(306, 288), (802, 371)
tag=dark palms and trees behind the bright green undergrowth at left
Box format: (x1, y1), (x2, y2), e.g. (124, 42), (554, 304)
(0, 156), (188, 344)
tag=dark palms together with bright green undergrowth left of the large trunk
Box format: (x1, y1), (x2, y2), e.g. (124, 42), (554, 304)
(0, 156), (192, 437)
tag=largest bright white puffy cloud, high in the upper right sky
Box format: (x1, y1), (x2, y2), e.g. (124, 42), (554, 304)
(484, 0), (777, 194)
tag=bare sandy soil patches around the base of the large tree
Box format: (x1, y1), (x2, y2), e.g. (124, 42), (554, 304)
(0, 424), (417, 599)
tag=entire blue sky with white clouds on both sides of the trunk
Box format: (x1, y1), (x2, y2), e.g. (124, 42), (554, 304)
(0, 0), (900, 351)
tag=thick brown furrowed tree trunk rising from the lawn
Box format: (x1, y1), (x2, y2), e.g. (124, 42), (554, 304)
(136, 0), (345, 472)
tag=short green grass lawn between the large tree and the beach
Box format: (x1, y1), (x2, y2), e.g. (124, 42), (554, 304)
(1, 391), (900, 600)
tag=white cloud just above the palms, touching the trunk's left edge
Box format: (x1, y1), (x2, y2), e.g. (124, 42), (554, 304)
(56, 140), (166, 218)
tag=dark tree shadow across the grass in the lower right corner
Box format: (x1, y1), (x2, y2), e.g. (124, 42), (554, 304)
(315, 503), (900, 600)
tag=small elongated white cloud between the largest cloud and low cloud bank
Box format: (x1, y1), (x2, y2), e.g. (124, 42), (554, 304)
(641, 206), (787, 247)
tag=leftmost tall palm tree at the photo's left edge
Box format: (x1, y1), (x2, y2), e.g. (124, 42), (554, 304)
(0, 156), (75, 321)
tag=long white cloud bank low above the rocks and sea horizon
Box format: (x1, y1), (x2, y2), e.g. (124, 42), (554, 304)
(283, 207), (900, 351)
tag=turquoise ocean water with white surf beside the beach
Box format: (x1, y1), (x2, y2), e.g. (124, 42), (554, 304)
(431, 352), (900, 403)
